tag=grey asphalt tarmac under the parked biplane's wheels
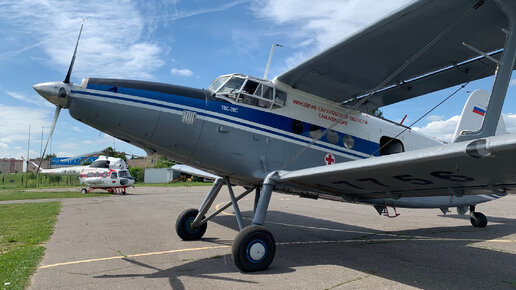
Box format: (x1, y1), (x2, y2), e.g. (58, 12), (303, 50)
(29, 187), (516, 289)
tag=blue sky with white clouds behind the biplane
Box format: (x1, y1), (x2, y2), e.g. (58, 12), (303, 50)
(0, 0), (516, 158)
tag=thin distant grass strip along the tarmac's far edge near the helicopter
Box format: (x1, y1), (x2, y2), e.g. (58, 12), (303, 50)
(0, 190), (107, 201)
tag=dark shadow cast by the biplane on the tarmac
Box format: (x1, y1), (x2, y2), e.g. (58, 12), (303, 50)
(95, 211), (516, 289)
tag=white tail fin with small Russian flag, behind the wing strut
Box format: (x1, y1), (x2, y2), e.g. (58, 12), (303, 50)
(453, 90), (507, 142)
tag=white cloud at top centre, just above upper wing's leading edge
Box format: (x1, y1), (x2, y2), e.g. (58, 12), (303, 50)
(253, 0), (411, 60)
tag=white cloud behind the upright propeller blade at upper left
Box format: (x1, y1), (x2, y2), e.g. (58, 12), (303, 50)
(0, 0), (164, 79)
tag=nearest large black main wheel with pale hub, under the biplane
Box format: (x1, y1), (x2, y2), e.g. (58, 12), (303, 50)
(231, 226), (276, 272)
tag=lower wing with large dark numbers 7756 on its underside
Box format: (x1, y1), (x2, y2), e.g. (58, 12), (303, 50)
(276, 134), (516, 199)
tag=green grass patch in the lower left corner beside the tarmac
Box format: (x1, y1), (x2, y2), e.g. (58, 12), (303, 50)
(0, 202), (61, 289)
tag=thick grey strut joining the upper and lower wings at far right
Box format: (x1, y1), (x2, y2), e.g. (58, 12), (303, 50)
(453, 0), (516, 143)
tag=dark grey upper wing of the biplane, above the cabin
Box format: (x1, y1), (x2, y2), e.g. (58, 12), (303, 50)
(278, 0), (508, 110)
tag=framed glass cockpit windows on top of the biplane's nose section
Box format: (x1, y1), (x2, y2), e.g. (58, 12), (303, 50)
(208, 74), (287, 109)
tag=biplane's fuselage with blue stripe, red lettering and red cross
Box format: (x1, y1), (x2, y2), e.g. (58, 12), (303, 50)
(31, 74), (500, 207)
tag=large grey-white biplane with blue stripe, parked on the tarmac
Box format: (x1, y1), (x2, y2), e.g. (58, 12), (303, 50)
(34, 0), (516, 272)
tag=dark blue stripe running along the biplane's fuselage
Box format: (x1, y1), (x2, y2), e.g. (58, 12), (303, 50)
(72, 85), (379, 158)
